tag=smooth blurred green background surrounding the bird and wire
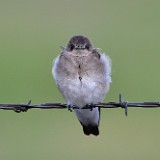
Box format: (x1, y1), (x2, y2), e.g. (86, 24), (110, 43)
(0, 0), (160, 160)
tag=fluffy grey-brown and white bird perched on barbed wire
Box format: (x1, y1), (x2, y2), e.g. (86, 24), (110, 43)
(52, 35), (111, 136)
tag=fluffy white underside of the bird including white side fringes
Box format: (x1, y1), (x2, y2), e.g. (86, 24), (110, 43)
(52, 54), (111, 107)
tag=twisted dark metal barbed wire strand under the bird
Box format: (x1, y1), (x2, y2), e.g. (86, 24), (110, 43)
(0, 94), (160, 116)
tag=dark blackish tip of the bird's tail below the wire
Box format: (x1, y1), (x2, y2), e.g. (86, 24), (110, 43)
(82, 125), (99, 136)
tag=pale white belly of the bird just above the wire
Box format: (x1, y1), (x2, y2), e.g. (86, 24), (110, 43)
(65, 77), (106, 107)
